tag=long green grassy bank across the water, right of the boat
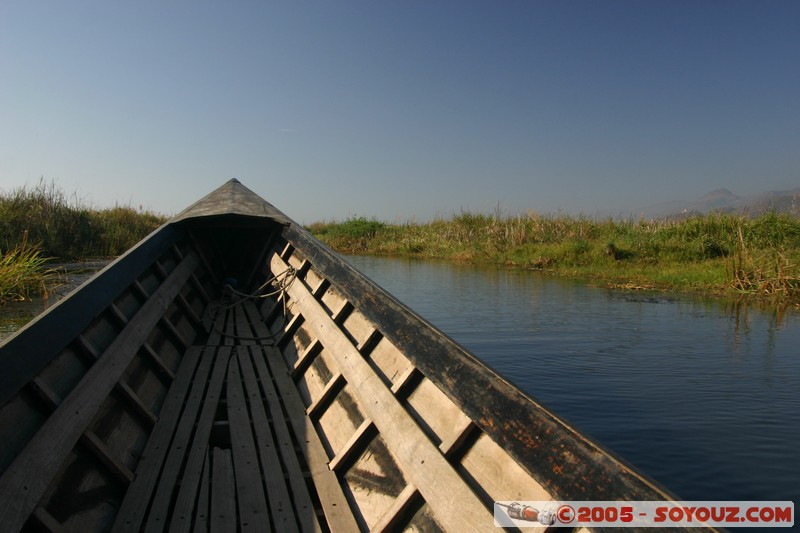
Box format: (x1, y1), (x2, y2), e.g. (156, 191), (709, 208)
(309, 213), (800, 303)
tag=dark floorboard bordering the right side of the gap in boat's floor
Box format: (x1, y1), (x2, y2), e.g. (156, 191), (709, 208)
(227, 346), (271, 532)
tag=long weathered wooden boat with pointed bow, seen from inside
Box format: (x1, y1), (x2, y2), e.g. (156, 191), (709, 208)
(0, 180), (712, 531)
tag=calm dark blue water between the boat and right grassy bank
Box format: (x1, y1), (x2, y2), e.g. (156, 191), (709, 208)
(348, 257), (800, 502)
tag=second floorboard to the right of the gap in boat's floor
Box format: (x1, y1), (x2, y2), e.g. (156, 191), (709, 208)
(238, 348), (304, 531)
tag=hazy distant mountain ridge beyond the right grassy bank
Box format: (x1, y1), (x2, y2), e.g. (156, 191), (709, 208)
(641, 187), (800, 218)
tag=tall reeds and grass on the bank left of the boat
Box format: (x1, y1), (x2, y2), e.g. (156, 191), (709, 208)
(0, 180), (165, 302)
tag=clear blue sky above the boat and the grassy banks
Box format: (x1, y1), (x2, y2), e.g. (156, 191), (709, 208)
(0, 0), (800, 222)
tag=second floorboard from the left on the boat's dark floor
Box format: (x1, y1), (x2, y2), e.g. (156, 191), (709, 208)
(145, 348), (219, 531)
